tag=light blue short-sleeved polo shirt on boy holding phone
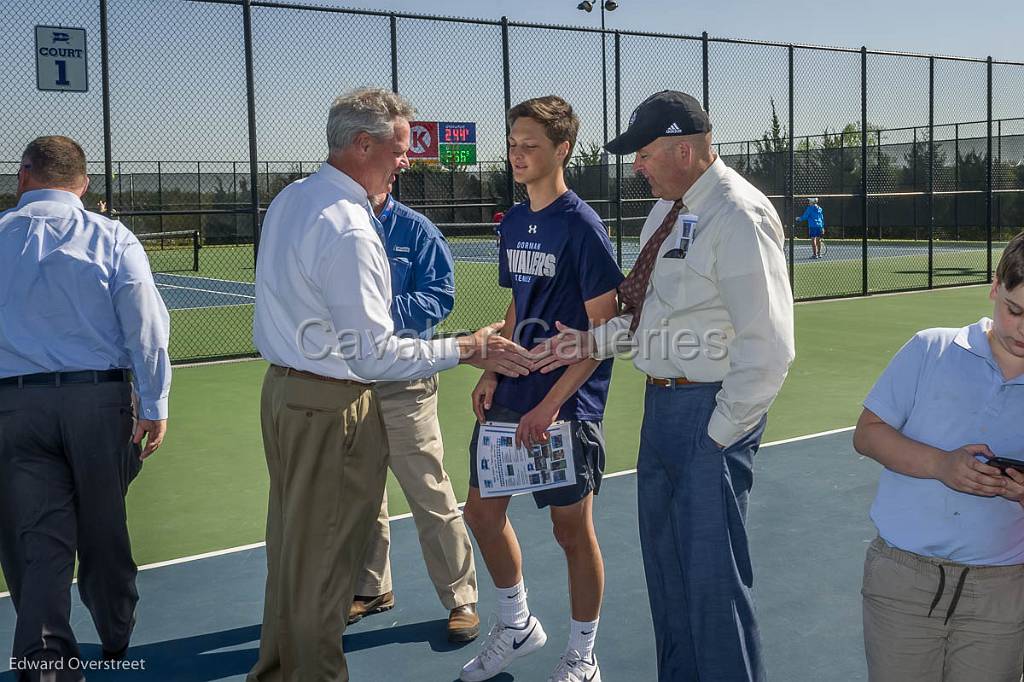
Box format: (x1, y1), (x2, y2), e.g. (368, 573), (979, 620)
(864, 317), (1024, 565)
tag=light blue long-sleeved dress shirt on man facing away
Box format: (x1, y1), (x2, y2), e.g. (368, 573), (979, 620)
(0, 189), (171, 419)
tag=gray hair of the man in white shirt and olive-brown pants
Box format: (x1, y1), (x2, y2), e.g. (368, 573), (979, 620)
(327, 88), (416, 152)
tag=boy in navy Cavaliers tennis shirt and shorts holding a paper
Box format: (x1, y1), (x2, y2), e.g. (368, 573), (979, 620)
(461, 96), (623, 682)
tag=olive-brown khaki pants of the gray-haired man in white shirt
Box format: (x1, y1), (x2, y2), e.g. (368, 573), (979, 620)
(248, 367), (388, 682)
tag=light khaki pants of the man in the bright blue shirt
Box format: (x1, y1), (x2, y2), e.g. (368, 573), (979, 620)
(355, 376), (477, 610)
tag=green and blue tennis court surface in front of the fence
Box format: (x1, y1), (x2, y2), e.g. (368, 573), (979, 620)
(0, 284), (991, 682)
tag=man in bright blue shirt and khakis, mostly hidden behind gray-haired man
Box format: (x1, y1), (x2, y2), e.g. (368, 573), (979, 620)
(349, 188), (480, 642)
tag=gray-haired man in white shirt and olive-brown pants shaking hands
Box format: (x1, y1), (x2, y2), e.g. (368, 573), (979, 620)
(248, 88), (531, 682)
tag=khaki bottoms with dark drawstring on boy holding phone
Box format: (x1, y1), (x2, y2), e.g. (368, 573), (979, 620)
(861, 538), (1024, 682)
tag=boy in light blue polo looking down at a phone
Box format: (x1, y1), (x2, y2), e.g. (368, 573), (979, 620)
(853, 233), (1024, 682)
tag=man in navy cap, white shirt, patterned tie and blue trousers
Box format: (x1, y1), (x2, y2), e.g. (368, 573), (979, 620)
(535, 90), (795, 682)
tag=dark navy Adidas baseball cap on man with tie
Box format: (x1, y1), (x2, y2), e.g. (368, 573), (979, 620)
(604, 90), (711, 154)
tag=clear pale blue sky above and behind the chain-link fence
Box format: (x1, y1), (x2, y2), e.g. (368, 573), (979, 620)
(0, 0), (1024, 165)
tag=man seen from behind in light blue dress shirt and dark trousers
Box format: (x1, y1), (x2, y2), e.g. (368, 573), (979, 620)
(0, 136), (171, 680)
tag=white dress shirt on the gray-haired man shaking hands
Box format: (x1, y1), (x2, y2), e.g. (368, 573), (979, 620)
(253, 163), (459, 382)
